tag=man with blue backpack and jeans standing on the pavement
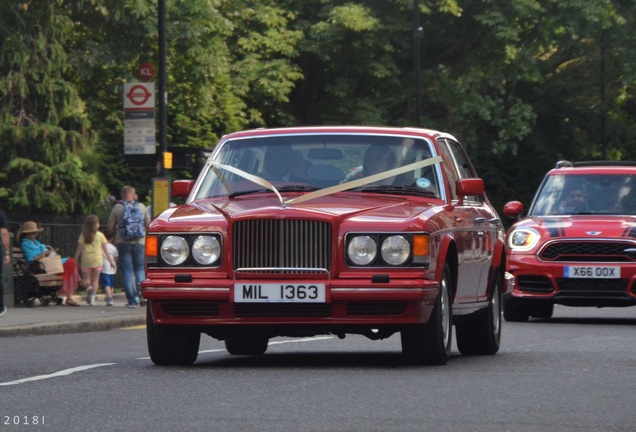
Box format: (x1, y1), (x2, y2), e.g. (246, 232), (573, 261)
(108, 186), (150, 308)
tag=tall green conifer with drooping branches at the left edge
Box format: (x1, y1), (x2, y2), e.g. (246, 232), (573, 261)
(0, 0), (105, 214)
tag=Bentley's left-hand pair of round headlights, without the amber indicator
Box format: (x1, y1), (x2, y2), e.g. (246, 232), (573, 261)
(159, 234), (221, 266)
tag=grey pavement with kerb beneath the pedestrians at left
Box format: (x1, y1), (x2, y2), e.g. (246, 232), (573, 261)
(0, 293), (146, 338)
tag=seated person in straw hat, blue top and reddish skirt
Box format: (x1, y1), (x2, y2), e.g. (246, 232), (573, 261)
(17, 221), (88, 306)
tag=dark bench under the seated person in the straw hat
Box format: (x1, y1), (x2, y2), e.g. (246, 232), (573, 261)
(13, 247), (64, 307)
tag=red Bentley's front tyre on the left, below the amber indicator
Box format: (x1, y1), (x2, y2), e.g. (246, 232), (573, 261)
(146, 304), (201, 366)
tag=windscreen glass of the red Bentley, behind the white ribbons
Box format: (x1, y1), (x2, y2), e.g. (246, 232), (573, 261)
(196, 134), (439, 199)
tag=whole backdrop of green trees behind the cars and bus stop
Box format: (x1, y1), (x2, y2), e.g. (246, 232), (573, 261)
(0, 0), (636, 213)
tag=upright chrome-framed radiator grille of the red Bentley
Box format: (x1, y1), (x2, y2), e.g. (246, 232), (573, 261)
(232, 219), (331, 270)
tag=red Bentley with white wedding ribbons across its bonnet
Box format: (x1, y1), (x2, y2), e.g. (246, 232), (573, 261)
(142, 127), (508, 365)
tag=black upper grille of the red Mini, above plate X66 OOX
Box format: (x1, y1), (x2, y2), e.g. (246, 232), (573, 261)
(539, 241), (636, 262)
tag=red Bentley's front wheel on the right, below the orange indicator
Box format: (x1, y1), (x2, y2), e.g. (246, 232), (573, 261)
(400, 264), (453, 365)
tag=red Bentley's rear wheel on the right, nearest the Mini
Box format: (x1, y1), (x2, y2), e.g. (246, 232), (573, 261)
(455, 274), (502, 355)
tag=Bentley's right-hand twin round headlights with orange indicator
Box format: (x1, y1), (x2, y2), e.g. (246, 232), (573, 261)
(346, 233), (430, 267)
